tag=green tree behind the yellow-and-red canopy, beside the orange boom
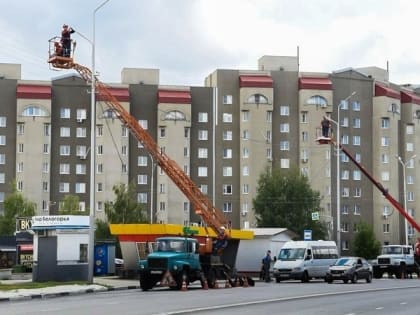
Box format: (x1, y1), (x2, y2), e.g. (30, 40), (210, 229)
(105, 183), (147, 224)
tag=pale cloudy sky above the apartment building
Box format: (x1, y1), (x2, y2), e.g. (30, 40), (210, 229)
(0, 0), (420, 86)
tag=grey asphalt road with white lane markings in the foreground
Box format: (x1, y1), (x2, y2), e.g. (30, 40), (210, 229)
(0, 279), (420, 315)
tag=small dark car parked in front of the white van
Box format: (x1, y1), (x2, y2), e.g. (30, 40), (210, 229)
(325, 257), (373, 283)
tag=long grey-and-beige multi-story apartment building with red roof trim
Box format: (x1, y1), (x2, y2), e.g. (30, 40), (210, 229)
(0, 56), (420, 252)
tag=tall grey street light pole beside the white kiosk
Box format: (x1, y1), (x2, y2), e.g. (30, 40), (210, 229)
(88, 0), (109, 283)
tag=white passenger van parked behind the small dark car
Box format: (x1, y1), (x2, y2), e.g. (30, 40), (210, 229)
(273, 241), (338, 283)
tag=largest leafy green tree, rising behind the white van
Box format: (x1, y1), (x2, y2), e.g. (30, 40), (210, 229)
(253, 168), (327, 239)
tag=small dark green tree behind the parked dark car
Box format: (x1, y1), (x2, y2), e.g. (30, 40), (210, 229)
(353, 222), (382, 259)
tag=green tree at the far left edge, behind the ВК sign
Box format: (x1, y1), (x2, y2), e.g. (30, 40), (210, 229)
(0, 185), (36, 235)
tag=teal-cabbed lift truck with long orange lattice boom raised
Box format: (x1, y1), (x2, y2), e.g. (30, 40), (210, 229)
(48, 37), (254, 291)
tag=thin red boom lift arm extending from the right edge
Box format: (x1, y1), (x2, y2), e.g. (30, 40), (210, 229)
(317, 137), (420, 232)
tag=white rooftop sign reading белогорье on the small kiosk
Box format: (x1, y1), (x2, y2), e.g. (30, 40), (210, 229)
(32, 215), (89, 230)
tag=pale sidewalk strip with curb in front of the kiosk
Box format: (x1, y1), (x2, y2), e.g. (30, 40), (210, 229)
(0, 275), (140, 302)
